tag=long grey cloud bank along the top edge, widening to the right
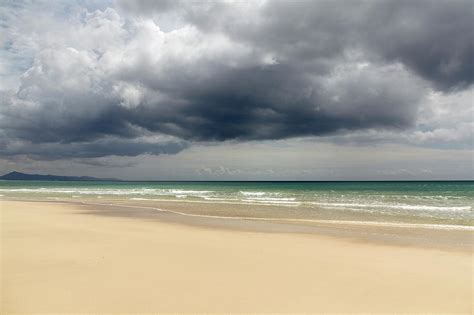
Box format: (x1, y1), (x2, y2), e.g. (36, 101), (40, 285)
(123, 0), (474, 90)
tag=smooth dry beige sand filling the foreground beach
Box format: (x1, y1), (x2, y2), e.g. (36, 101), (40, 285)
(0, 201), (473, 314)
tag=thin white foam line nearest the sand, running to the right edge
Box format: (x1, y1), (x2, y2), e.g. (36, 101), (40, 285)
(78, 201), (474, 231)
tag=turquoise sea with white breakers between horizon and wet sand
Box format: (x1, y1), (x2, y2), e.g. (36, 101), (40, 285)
(0, 181), (474, 226)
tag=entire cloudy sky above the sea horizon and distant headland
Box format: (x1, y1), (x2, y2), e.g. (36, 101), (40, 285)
(0, 0), (474, 180)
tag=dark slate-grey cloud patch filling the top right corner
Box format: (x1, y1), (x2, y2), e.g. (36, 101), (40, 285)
(367, 0), (474, 89)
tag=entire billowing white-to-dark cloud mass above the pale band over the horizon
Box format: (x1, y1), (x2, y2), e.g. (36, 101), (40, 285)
(0, 0), (474, 159)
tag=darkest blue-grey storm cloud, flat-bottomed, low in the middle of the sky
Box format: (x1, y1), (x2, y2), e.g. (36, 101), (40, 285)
(130, 65), (419, 141)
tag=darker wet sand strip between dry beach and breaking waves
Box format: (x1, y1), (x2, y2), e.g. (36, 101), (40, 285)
(74, 199), (474, 253)
